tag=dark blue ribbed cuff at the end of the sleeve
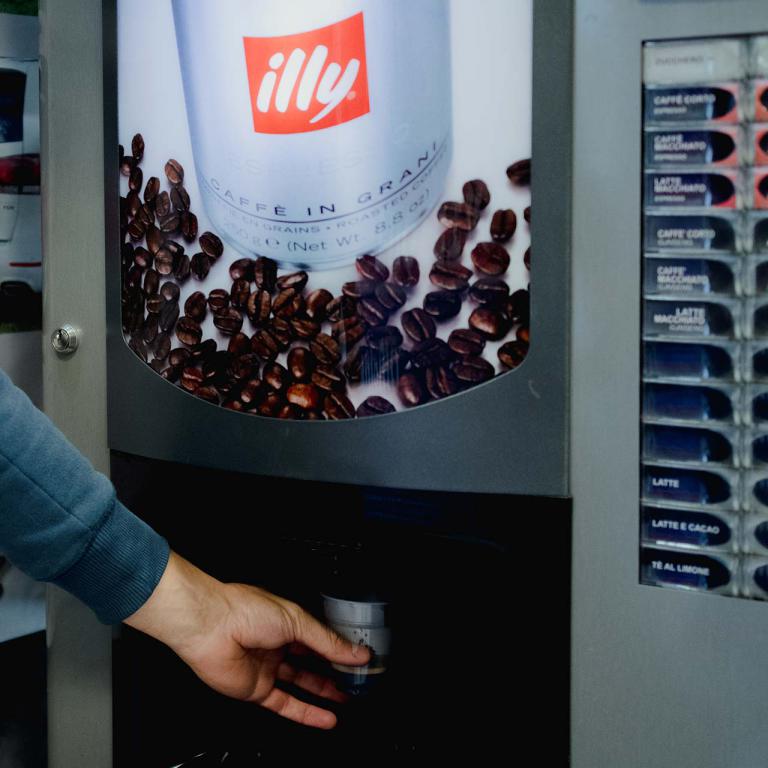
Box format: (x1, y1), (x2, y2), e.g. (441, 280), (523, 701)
(53, 499), (170, 624)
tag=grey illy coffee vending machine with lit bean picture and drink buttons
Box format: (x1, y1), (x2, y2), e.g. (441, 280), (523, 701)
(41, 0), (768, 768)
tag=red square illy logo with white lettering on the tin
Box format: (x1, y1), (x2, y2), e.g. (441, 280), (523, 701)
(243, 13), (370, 133)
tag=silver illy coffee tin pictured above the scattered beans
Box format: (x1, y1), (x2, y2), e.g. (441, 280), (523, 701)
(173, 0), (451, 269)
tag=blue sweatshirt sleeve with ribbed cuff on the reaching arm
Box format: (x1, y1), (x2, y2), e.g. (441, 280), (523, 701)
(0, 371), (169, 624)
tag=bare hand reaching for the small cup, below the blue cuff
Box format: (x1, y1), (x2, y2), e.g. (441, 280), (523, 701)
(125, 552), (370, 729)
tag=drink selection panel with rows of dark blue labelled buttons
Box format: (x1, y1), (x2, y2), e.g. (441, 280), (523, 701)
(640, 35), (768, 599)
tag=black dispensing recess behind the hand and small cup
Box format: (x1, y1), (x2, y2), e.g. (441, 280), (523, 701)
(113, 454), (571, 768)
